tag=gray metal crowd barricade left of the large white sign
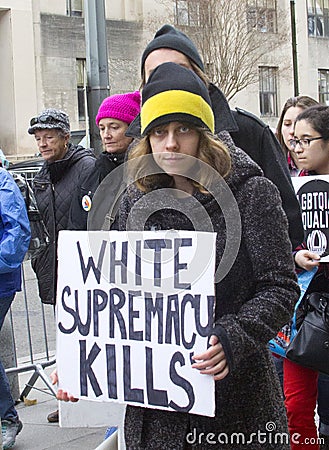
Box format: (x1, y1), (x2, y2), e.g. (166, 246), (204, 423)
(5, 261), (56, 401)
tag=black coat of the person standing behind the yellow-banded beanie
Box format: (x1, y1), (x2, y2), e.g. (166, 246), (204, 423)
(126, 84), (304, 249)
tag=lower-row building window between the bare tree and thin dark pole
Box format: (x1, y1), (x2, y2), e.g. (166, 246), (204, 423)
(259, 66), (278, 117)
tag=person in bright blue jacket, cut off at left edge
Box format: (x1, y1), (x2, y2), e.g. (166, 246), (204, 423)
(0, 167), (30, 450)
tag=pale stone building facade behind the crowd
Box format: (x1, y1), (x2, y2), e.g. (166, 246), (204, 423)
(0, 0), (329, 161)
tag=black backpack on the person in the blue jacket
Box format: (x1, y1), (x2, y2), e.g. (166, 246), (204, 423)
(10, 172), (49, 259)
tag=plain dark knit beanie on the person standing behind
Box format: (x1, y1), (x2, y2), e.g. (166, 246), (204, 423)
(141, 25), (204, 74)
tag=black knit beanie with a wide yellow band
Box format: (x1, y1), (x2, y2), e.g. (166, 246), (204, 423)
(140, 62), (215, 136)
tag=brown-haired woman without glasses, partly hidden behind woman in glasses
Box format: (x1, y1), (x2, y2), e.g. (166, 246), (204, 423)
(276, 95), (319, 176)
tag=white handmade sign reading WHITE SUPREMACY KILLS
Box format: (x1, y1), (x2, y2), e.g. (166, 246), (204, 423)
(56, 230), (216, 416)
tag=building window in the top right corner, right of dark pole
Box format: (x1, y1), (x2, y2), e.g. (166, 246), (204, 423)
(307, 0), (329, 37)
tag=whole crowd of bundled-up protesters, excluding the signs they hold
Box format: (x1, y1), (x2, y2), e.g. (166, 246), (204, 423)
(0, 25), (329, 450)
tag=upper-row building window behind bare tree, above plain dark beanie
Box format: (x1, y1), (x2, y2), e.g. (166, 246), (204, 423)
(174, 0), (210, 27)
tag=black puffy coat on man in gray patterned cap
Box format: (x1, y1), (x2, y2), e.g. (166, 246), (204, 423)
(31, 144), (95, 304)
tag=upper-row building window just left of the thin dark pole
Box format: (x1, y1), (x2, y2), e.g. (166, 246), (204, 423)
(247, 0), (277, 33)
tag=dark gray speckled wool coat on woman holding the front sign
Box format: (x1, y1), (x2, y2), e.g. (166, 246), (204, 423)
(119, 132), (299, 450)
